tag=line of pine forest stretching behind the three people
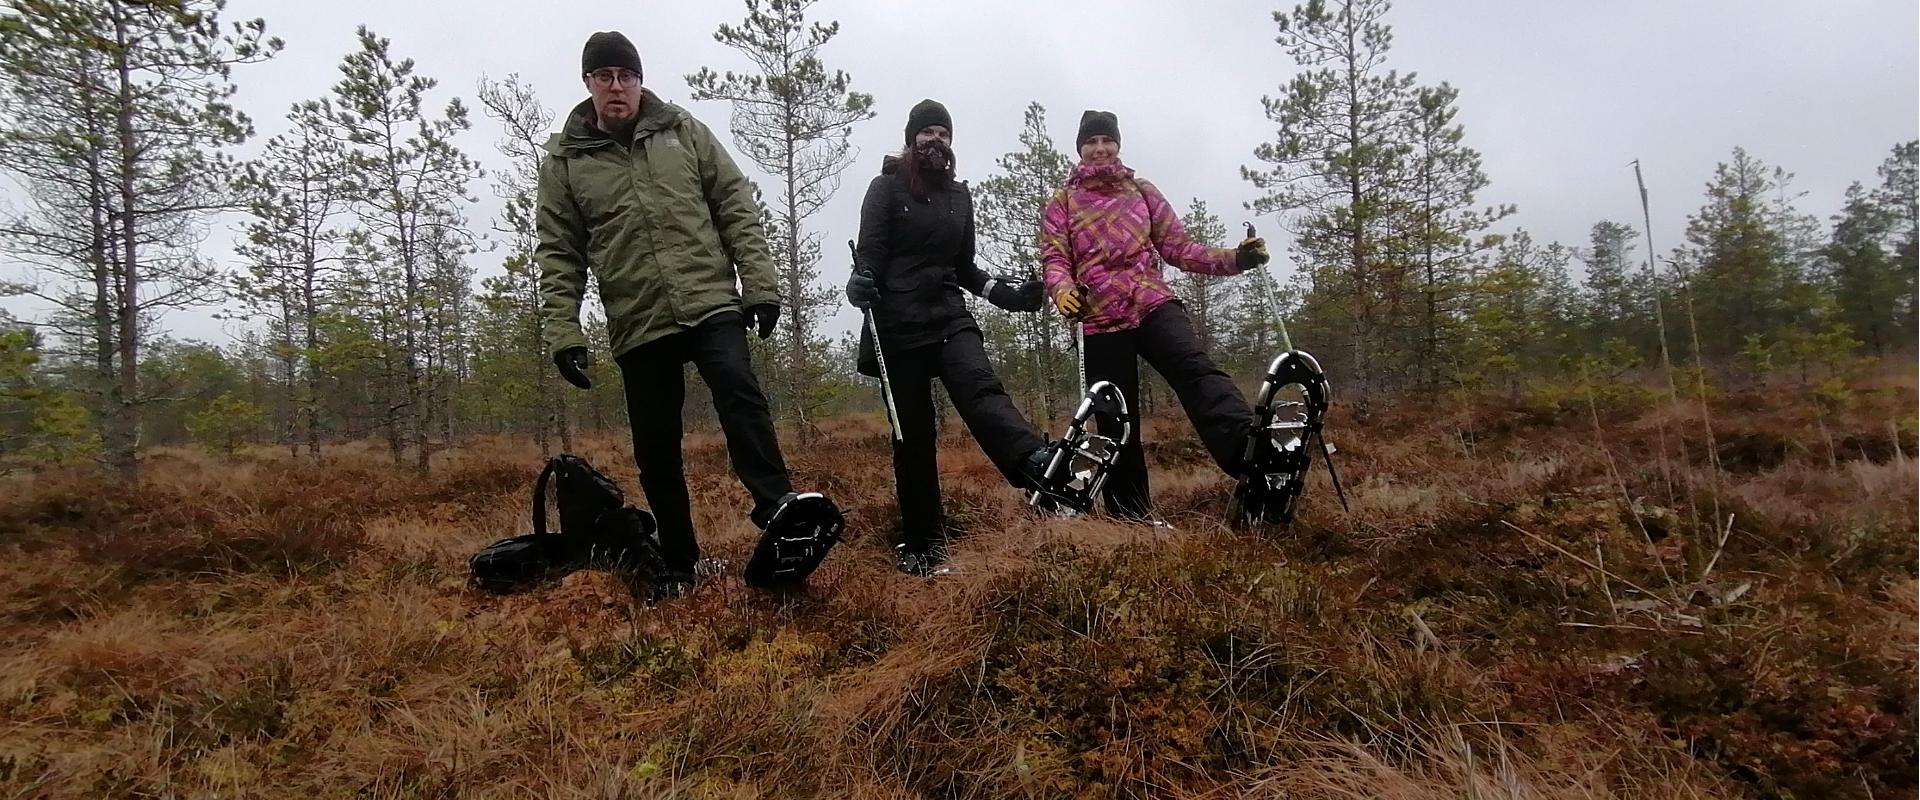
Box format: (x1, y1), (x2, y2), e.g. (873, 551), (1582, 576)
(0, 0), (1920, 476)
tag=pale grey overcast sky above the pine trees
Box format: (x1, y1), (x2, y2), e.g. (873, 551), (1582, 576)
(0, 0), (1920, 340)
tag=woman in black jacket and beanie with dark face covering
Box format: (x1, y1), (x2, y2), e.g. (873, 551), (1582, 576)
(847, 100), (1046, 576)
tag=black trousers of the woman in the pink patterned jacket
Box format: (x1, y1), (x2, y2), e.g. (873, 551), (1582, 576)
(1085, 301), (1254, 518)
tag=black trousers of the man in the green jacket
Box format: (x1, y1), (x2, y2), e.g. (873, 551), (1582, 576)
(618, 311), (793, 576)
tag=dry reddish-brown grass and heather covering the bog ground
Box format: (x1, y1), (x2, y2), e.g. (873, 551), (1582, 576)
(0, 376), (1916, 800)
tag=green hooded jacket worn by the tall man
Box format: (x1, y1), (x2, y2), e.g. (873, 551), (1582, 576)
(534, 90), (780, 357)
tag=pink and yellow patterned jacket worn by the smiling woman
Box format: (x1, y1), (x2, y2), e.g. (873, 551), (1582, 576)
(1041, 161), (1240, 336)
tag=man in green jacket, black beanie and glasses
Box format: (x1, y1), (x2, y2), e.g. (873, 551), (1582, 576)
(534, 33), (829, 599)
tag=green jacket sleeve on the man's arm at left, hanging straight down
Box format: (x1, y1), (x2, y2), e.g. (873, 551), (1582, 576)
(534, 157), (588, 353)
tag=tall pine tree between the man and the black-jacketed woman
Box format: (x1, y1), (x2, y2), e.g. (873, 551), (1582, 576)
(687, 0), (874, 439)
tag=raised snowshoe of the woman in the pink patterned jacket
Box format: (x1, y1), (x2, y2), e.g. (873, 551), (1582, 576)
(1233, 349), (1346, 526)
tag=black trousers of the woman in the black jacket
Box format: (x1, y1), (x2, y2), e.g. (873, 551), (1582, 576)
(881, 330), (1046, 549)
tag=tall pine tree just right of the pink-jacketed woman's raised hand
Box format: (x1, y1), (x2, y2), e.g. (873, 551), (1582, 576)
(1240, 0), (1413, 403)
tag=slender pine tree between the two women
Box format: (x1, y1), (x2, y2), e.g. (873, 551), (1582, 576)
(973, 104), (1079, 420)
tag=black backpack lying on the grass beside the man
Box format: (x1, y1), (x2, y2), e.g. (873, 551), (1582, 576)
(467, 455), (664, 593)
